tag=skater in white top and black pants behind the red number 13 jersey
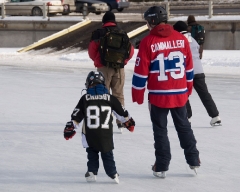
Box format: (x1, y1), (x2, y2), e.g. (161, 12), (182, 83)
(173, 21), (221, 126)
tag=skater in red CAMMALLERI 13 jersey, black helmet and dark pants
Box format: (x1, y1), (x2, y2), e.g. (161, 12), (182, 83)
(132, 6), (200, 178)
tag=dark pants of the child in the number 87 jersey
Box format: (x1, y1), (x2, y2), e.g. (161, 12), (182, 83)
(86, 147), (117, 177)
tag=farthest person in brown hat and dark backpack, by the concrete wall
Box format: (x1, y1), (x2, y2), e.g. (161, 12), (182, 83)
(187, 15), (205, 59)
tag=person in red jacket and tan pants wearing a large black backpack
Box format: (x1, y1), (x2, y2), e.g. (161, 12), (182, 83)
(88, 11), (134, 132)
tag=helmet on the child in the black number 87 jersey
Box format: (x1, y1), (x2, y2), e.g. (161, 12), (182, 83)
(85, 71), (105, 88)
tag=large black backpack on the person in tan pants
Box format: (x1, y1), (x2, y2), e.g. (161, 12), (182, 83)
(99, 28), (131, 69)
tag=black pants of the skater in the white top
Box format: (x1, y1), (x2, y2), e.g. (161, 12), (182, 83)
(186, 73), (219, 118)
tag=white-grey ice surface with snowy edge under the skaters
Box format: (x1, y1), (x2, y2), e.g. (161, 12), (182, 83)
(0, 48), (240, 192)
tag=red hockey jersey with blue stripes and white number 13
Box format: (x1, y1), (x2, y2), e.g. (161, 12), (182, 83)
(132, 24), (193, 108)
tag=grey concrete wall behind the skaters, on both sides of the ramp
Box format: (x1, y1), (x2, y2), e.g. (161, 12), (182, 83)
(0, 21), (240, 50)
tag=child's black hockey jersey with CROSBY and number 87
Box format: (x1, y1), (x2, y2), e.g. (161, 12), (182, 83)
(71, 94), (129, 153)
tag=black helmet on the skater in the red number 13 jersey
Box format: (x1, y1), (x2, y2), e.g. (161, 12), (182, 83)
(144, 6), (168, 25)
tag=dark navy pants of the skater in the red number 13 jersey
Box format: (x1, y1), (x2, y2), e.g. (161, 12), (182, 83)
(150, 105), (199, 172)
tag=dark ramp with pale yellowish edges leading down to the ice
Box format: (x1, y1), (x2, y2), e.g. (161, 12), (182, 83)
(18, 21), (147, 52)
